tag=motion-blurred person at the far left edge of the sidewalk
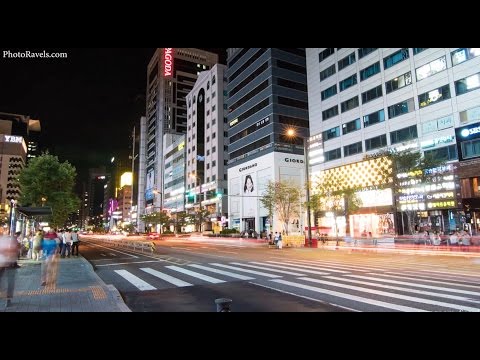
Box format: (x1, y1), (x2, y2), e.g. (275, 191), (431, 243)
(0, 236), (20, 307)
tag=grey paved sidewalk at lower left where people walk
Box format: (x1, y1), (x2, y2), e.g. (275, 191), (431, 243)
(0, 255), (130, 312)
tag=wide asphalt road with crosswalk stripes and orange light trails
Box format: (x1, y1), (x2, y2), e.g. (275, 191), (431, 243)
(80, 237), (480, 312)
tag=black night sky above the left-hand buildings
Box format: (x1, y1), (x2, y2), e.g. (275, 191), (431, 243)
(0, 48), (226, 186)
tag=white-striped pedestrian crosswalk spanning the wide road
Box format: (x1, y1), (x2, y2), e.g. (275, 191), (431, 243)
(110, 259), (480, 312)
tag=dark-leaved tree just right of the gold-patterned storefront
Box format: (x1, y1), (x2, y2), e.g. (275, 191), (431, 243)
(382, 149), (445, 234)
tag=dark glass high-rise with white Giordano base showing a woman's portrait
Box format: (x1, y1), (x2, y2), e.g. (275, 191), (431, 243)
(226, 48), (309, 234)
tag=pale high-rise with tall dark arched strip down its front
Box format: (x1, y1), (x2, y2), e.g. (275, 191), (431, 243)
(184, 64), (228, 234)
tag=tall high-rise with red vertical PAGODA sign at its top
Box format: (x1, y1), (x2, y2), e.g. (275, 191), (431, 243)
(138, 48), (218, 230)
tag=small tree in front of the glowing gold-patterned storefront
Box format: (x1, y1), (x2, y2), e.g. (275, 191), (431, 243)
(310, 171), (362, 241)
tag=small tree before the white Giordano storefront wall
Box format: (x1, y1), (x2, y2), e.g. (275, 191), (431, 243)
(260, 180), (303, 235)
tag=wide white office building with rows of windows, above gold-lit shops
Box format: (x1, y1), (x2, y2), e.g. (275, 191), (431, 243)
(307, 48), (480, 236)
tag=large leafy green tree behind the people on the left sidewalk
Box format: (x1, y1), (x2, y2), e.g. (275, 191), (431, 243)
(18, 153), (80, 227)
